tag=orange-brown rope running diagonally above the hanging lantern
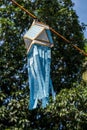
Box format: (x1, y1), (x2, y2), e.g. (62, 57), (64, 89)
(11, 0), (87, 56)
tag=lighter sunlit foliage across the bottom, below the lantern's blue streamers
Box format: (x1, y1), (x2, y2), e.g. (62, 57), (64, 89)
(0, 86), (87, 130)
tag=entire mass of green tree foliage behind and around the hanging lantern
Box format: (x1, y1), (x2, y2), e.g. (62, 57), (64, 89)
(0, 0), (87, 130)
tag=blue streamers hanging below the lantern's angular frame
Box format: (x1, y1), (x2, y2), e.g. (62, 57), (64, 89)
(28, 44), (55, 110)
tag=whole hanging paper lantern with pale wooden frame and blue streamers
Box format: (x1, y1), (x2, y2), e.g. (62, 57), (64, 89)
(24, 21), (55, 109)
